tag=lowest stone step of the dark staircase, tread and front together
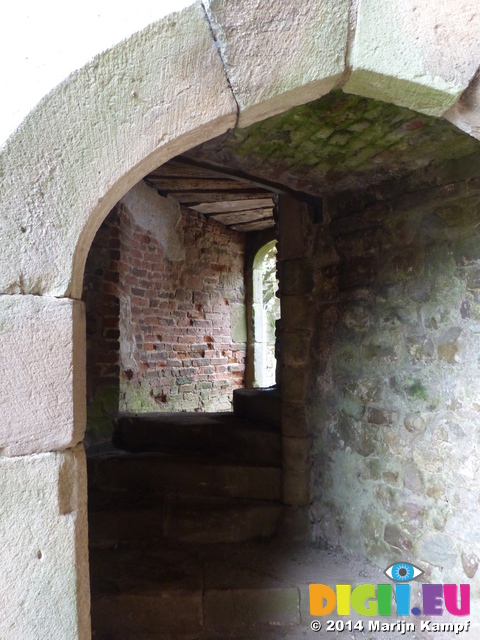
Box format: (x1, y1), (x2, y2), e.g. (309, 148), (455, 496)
(91, 544), (301, 640)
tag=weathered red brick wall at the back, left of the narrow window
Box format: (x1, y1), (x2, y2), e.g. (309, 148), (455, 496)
(84, 182), (245, 438)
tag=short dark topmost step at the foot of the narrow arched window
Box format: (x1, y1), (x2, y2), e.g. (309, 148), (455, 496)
(233, 387), (282, 430)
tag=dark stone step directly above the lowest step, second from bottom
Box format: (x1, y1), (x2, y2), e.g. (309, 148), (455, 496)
(89, 491), (283, 547)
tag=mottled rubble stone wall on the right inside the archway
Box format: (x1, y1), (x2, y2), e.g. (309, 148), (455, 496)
(306, 155), (480, 582)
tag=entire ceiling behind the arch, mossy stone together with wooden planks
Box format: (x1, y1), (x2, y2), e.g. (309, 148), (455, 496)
(146, 89), (480, 232)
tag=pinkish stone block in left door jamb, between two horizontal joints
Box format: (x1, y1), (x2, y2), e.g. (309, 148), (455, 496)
(0, 295), (86, 455)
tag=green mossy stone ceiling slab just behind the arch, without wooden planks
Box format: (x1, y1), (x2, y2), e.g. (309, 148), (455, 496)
(188, 89), (478, 194)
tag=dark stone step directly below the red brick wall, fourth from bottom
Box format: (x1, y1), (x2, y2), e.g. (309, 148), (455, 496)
(113, 413), (282, 466)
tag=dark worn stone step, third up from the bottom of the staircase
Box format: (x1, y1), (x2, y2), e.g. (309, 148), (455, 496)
(88, 452), (281, 500)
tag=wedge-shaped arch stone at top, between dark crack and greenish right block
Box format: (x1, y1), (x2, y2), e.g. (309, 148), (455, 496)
(202, 0), (350, 127)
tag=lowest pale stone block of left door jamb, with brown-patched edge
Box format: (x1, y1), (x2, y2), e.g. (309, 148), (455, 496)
(0, 447), (90, 640)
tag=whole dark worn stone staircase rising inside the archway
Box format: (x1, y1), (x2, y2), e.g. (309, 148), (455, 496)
(88, 392), (316, 640)
